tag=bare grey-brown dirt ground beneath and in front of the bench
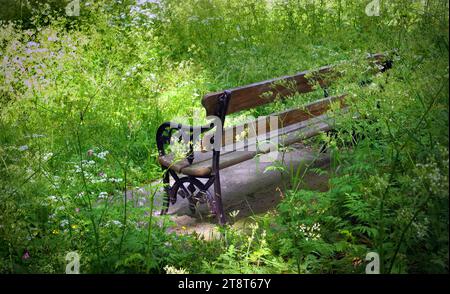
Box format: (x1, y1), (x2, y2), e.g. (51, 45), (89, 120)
(139, 144), (329, 239)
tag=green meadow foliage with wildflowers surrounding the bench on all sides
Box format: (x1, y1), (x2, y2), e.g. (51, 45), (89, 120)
(0, 0), (449, 273)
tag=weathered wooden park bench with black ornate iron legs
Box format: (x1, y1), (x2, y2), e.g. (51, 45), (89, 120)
(156, 54), (391, 224)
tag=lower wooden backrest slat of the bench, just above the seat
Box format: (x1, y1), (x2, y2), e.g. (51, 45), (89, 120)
(203, 95), (346, 146)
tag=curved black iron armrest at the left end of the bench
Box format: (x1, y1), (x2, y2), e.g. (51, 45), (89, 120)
(156, 122), (214, 164)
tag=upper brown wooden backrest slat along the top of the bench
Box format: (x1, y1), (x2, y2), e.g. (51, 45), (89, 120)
(202, 66), (331, 115)
